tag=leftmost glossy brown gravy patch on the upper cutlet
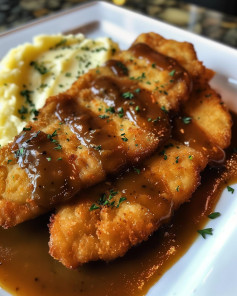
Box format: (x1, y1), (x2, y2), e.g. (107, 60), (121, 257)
(12, 131), (78, 206)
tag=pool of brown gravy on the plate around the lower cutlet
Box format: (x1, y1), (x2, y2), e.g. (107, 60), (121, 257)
(0, 115), (237, 296)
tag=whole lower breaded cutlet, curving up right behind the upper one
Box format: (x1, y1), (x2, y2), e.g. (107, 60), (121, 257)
(49, 76), (231, 268)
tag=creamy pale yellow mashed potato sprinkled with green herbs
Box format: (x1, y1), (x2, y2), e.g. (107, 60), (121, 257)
(0, 34), (118, 146)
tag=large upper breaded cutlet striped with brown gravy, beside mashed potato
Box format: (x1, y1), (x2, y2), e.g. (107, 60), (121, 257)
(0, 34), (196, 228)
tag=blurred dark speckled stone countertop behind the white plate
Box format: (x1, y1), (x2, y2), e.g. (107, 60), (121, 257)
(0, 0), (237, 48)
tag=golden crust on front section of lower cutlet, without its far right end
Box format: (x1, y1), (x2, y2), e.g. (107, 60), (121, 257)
(49, 143), (207, 268)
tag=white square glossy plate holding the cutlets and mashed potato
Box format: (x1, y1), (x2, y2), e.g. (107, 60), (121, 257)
(0, 2), (237, 296)
